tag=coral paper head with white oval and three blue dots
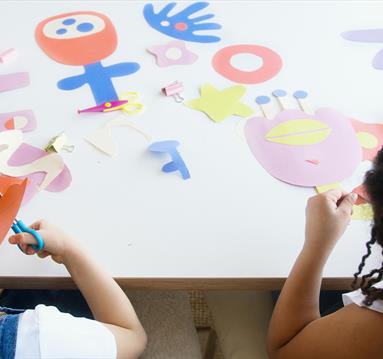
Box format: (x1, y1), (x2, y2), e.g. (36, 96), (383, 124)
(35, 11), (117, 65)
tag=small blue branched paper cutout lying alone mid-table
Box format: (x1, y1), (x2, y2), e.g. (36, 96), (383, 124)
(149, 140), (190, 180)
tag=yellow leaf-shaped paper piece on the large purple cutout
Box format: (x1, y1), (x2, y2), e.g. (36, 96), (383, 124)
(266, 119), (331, 145)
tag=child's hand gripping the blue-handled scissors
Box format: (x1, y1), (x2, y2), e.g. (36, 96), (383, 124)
(9, 220), (77, 263)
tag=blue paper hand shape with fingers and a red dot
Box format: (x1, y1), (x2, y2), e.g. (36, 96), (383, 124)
(144, 2), (222, 43)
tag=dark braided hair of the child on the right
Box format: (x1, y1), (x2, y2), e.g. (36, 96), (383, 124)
(352, 148), (383, 306)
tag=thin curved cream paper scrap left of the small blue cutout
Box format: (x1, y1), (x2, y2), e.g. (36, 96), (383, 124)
(85, 116), (151, 157)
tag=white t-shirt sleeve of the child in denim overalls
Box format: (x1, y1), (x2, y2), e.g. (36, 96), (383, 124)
(15, 305), (117, 359)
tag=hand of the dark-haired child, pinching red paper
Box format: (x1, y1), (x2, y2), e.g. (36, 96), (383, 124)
(305, 189), (358, 253)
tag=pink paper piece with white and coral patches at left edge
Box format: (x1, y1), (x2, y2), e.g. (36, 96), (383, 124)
(0, 110), (37, 132)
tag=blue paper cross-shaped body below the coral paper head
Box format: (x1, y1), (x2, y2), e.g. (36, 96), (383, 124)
(57, 62), (140, 105)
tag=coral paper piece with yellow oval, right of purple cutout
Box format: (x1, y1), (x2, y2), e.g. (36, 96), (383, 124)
(351, 119), (383, 161)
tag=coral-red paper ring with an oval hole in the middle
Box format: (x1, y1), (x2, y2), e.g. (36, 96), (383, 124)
(212, 45), (282, 84)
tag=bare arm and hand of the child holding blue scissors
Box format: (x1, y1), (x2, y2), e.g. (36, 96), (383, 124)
(9, 221), (146, 359)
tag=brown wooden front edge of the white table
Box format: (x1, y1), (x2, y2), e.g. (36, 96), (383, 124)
(0, 276), (352, 290)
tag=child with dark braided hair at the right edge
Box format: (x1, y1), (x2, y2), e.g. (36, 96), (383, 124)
(267, 149), (383, 359)
